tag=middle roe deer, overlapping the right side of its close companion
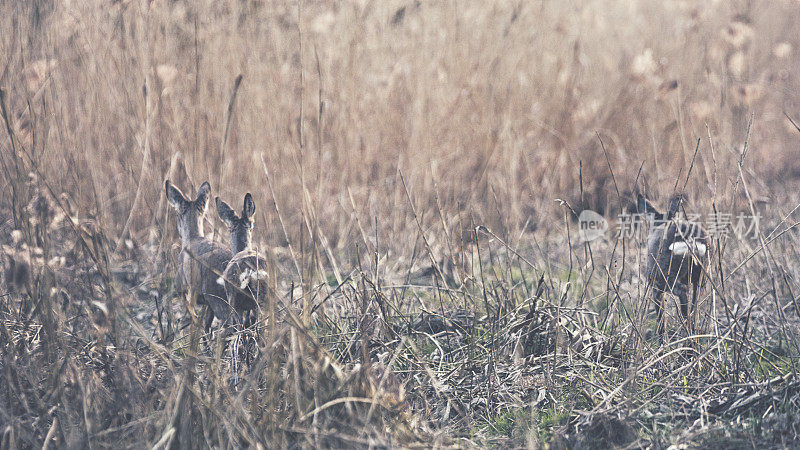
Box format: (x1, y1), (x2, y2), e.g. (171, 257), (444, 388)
(216, 193), (276, 327)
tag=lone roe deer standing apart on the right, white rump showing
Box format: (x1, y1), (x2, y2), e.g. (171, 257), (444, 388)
(636, 194), (711, 336)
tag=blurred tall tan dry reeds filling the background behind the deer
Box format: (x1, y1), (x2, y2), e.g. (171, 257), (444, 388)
(0, 0), (800, 247)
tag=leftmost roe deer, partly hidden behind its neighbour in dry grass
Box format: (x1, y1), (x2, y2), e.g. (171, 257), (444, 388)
(165, 180), (231, 332)
